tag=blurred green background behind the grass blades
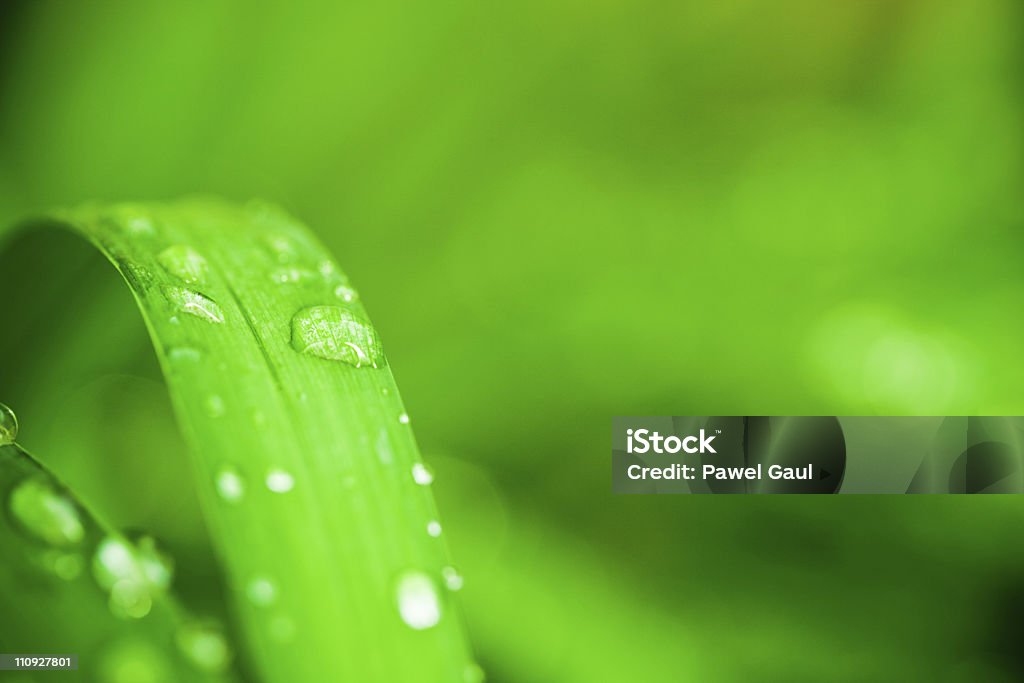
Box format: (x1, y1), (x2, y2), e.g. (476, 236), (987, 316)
(0, 0), (1024, 682)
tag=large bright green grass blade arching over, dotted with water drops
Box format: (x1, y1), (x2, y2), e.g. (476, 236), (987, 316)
(0, 200), (475, 683)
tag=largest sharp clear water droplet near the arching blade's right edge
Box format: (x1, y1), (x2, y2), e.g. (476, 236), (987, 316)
(292, 306), (384, 368)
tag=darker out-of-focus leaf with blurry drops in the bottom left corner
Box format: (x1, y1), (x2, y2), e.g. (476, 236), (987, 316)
(0, 438), (230, 682)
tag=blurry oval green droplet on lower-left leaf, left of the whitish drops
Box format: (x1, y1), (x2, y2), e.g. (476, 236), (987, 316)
(8, 478), (85, 546)
